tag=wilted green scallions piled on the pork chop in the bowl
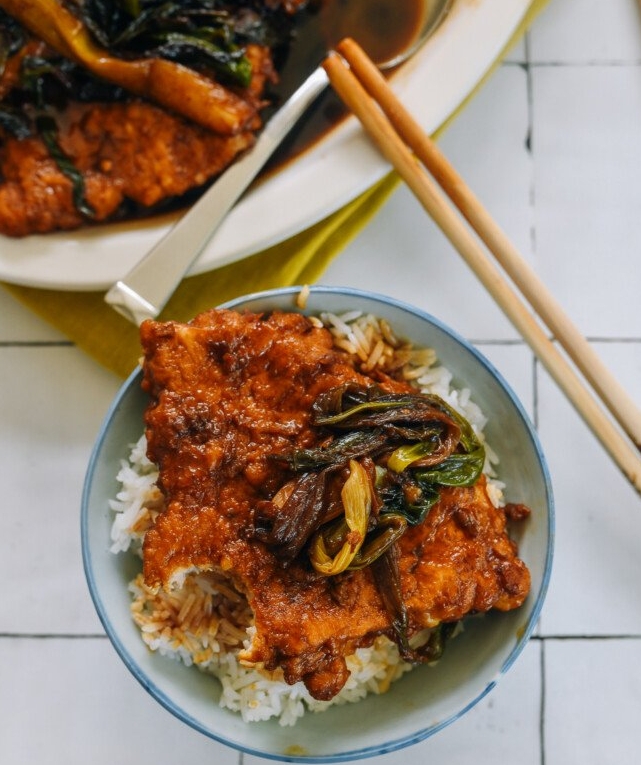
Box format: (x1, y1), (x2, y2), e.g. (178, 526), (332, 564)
(256, 383), (485, 662)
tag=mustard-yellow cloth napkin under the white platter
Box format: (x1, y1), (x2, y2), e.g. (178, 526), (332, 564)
(3, 0), (548, 377)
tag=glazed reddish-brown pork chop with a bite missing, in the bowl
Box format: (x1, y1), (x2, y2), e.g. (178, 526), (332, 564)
(141, 310), (530, 699)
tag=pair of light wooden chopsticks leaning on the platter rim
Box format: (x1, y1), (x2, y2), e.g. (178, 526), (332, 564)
(323, 39), (641, 494)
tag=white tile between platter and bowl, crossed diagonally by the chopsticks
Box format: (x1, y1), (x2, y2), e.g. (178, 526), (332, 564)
(322, 65), (532, 339)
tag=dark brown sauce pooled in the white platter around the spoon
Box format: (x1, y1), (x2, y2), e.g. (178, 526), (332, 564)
(264, 0), (438, 173)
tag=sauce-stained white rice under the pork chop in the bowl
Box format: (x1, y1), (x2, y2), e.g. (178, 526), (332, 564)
(110, 311), (503, 726)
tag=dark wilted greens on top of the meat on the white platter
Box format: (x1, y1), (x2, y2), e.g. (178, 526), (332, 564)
(0, 0), (300, 217)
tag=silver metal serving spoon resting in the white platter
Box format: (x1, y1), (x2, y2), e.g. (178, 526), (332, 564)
(105, 0), (454, 325)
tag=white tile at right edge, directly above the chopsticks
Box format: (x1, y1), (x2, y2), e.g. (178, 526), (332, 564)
(532, 66), (641, 337)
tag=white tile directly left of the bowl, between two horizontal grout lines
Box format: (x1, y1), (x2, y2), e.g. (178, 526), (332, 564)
(0, 346), (120, 634)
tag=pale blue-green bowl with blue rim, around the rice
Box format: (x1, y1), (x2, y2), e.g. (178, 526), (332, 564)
(81, 287), (553, 762)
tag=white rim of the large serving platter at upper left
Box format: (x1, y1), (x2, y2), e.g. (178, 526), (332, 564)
(0, 0), (531, 290)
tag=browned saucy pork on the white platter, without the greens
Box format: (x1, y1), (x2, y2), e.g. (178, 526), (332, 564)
(0, 38), (275, 236)
